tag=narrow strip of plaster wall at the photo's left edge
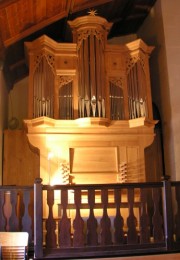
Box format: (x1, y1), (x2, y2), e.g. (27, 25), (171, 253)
(0, 63), (8, 185)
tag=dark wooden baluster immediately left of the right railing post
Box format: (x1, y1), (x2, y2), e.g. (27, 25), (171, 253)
(152, 188), (164, 242)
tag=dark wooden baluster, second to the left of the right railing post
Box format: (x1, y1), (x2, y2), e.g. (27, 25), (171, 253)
(140, 188), (150, 244)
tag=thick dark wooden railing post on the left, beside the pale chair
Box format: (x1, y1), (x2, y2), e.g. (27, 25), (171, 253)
(34, 178), (43, 258)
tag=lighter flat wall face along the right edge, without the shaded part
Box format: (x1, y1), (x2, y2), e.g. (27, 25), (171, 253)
(161, 0), (180, 180)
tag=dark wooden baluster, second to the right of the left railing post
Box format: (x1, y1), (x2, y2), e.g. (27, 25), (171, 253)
(58, 190), (71, 247)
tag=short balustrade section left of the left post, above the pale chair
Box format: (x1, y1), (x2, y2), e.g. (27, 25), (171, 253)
(0, 186), (34, 243)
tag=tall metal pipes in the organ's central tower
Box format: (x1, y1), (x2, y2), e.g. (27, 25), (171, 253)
(79, 30), (105, 117)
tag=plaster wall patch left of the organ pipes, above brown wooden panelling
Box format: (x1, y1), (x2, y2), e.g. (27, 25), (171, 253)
(8, 77), (28, 129)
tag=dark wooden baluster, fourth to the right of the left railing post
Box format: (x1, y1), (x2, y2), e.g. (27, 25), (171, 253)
(87, 190), (98, 246)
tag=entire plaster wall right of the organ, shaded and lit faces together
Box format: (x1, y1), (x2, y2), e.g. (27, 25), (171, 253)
(138, 0), (180, 180)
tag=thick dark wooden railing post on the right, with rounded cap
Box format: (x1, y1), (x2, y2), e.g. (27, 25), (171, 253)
(163, 180), (174, 250)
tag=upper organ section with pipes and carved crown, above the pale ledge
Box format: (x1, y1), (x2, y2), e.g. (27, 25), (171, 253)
(27, 16), (153, 120)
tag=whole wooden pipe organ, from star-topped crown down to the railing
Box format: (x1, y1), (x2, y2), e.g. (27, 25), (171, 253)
(25, 15), (156, 184)
